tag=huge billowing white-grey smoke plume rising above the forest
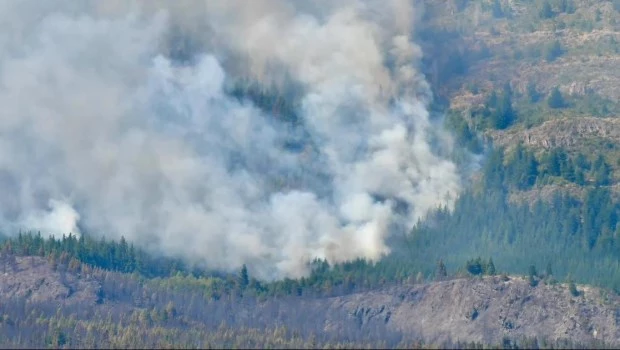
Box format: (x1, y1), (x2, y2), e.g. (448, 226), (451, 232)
(0, 0), (460, 279)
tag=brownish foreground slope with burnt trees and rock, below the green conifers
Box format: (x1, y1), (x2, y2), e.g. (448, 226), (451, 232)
(0, 256), (620, 348)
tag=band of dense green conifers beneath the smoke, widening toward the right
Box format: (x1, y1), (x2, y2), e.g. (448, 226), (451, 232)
(2, 133), (620, 297)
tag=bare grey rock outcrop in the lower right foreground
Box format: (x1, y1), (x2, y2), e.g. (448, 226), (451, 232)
(330, 277), (620, 344)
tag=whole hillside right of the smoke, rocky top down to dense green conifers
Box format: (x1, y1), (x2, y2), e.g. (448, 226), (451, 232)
(402, 0), (620, 290)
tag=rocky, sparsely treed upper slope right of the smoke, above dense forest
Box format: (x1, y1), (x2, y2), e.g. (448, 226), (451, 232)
(420, 0), (620, 200)
